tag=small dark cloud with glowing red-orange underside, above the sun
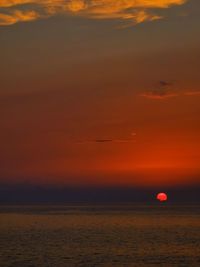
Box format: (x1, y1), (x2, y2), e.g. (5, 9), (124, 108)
(140, 81), (178, 99)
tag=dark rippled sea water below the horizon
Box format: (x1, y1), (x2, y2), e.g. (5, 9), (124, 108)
(0, 204), (200, 267)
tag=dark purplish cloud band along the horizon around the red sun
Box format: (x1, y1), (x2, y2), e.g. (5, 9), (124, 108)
(0, 184), (200, 205)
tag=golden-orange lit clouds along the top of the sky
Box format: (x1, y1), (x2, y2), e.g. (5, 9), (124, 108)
(0, 0), (187, 25)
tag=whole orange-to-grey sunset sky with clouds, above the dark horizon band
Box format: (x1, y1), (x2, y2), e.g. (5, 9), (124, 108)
(0, 0), (200, 187)
